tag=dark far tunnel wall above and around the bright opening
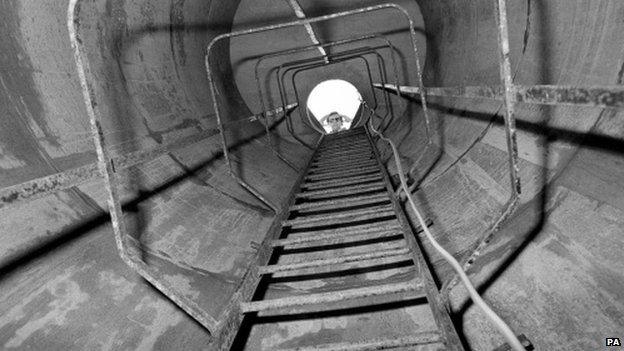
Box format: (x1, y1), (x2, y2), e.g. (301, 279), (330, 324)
(231, 0), (427, 145)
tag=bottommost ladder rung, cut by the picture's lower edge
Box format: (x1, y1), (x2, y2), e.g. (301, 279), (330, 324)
(279, 331), (443, 351)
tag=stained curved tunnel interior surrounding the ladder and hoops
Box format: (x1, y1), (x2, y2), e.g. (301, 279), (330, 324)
(0, 0), (624, 350)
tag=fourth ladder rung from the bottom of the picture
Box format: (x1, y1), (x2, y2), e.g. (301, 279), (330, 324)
(271, 228), (402, 249)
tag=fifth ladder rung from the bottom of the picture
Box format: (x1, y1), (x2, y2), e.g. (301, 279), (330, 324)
(282, 205), (395, 226)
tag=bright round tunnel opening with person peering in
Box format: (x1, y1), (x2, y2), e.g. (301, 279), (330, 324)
(306, 79), (362, 134)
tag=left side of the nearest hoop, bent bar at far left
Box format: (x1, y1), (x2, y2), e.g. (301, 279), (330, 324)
(67, 0), (217, 333)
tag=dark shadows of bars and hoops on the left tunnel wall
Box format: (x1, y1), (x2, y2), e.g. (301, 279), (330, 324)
(0, 5), (312, 296)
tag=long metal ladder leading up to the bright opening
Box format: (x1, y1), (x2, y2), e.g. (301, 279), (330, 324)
(241, 127), (463, 350)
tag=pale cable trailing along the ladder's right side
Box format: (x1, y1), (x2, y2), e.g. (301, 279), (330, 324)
(362, 101), (526, 351)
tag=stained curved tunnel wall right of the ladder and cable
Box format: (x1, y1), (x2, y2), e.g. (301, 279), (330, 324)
(389, 0), (624, 350)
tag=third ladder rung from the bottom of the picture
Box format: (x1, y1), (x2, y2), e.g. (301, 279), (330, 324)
(258, 247), (413, 274)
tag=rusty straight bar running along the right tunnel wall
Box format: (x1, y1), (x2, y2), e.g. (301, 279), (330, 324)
(375, 83), (624, 108)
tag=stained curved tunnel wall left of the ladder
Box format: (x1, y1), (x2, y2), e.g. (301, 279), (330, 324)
(0, 0), (309, 350)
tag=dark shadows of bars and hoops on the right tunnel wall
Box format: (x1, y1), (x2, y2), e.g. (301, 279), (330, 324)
(398, 1), (624, 346)
